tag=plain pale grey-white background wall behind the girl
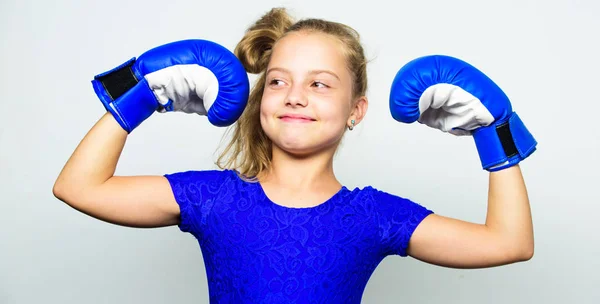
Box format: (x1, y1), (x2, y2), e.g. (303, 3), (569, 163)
(0, 0), (600, 304)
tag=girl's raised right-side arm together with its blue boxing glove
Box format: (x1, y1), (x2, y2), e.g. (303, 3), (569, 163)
(390, 55), (537, 268)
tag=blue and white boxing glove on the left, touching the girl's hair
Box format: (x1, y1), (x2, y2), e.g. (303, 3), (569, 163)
(92, 39), (250, 133)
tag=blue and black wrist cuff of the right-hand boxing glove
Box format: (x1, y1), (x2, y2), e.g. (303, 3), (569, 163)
(473, 112), (537, 172)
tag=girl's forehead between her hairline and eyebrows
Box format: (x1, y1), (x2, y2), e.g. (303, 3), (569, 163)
(269, 32), (347, 77)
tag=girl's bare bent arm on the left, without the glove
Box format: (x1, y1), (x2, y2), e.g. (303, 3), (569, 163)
(52, 112), (179, 228)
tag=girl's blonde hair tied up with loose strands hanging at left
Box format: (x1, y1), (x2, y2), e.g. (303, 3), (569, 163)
(216, 8), (367, 180)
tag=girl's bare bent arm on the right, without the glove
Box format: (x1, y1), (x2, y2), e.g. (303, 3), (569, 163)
(407, 165), (534, 268)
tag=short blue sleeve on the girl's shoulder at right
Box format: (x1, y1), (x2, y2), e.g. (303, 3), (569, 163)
(376, 191), (433, 257)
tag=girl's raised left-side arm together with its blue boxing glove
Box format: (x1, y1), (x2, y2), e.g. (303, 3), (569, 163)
(53, 40), (249, 227)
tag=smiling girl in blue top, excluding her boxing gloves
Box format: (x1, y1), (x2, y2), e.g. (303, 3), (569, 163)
(54, 9), (533, 303)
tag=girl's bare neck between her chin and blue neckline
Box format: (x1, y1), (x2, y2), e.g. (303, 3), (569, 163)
(258, 147), (341, 190)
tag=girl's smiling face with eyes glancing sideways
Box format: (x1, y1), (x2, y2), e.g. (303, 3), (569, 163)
(260, 33), (352, 154)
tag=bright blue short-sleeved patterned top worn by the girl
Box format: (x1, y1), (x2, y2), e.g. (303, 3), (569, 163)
(165, 170), (432, 304)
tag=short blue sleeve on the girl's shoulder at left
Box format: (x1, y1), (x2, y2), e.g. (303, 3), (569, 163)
(164, 170), (225, 237)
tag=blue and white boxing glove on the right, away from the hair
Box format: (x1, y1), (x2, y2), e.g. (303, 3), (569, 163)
(390, 55), (537, 172)
